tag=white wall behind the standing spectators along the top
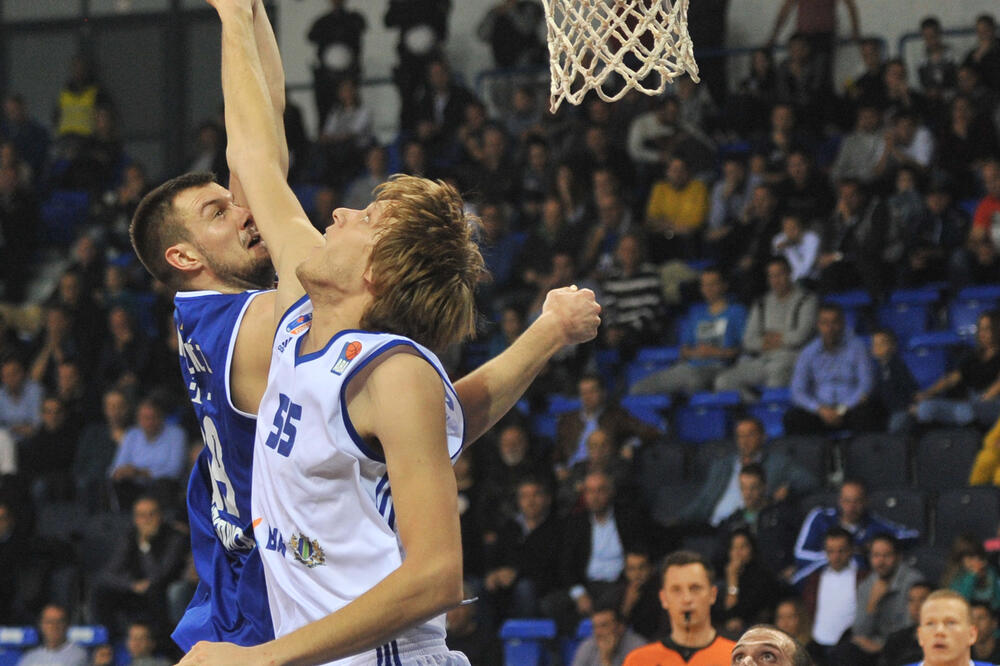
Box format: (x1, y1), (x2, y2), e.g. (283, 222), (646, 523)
(278, 0), (1000, 132)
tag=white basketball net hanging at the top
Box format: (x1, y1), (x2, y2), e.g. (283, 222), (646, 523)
(542, 0), (698, 113)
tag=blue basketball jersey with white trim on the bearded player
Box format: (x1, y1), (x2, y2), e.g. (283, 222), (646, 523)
(172, 291), (274, 652)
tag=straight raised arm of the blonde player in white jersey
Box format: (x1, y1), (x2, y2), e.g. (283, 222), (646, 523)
(209, 0), (321, 323)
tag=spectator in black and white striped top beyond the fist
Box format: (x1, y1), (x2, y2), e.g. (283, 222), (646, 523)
(600, 233), (666, 362)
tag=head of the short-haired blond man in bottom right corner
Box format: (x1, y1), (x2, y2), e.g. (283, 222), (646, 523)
(908, 590), (985, 666)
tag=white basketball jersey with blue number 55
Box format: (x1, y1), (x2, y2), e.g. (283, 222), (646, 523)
(252, 297), (465, 665)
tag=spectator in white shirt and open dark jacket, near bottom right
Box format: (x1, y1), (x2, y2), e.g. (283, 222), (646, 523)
(801, 525), (862, 664)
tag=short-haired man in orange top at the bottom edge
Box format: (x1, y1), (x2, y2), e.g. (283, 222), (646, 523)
(624, 550), (736, 666)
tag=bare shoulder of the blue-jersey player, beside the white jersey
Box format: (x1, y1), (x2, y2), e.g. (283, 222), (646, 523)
(229, 291), (277, 414)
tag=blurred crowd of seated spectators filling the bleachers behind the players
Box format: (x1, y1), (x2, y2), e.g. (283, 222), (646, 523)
(0, 3), (1000, 666)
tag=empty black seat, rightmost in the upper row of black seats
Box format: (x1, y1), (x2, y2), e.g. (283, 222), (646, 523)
(914, 428), (980, 490)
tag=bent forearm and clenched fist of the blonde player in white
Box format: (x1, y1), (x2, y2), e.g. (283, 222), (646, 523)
(455, 286), (601, 446)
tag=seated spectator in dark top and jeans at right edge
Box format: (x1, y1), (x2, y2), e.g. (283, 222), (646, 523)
(913, 312), (1000, 426)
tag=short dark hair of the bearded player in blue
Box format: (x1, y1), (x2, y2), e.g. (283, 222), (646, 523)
(129, 171), (215, 288)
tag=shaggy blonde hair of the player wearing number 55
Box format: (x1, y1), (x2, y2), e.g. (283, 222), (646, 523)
(361, 174), (485, 351)
